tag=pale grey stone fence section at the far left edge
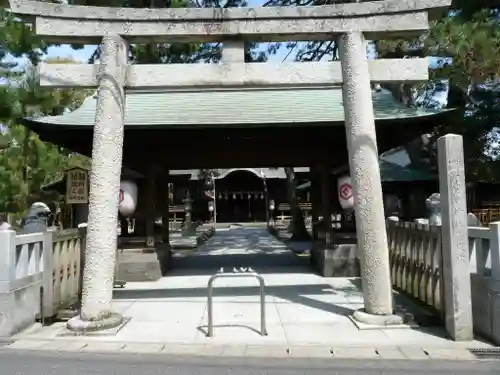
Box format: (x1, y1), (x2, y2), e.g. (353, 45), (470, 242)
(0, 230), (46, 337)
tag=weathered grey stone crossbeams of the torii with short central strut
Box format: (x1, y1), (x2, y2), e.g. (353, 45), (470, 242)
(10, 0), (450, 89)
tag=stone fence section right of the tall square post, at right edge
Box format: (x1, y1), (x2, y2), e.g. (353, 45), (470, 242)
(469, 222), (500, 345)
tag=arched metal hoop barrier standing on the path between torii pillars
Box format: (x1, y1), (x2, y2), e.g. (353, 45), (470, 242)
(207, 267), (267, 337)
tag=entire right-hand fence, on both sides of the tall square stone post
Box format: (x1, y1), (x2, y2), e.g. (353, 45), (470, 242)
(387, 220), (500, 344)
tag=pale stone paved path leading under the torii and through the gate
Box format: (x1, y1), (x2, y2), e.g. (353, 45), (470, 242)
(9, 228), (494, 358)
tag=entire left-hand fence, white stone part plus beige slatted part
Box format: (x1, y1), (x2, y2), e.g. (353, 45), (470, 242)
(0, 229), (85, 337)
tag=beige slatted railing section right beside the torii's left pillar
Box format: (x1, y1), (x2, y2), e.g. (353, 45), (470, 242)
(43, 229), (85, 317)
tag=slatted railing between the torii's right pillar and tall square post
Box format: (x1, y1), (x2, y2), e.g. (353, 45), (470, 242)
(387, 220), (444, 316)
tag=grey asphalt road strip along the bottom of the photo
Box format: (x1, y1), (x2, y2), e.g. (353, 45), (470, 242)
(0, 350), (498, 375)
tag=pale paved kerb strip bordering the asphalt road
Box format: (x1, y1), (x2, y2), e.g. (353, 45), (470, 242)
(4, 338), (488, 361)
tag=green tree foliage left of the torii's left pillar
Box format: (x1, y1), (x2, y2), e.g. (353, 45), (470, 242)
(0, 2), (87, 215)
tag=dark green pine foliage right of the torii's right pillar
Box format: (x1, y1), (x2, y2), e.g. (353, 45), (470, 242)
(377, 5), (500, 181)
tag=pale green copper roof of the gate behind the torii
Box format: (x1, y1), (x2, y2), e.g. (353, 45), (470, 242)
(29, 87), (446, 127)
